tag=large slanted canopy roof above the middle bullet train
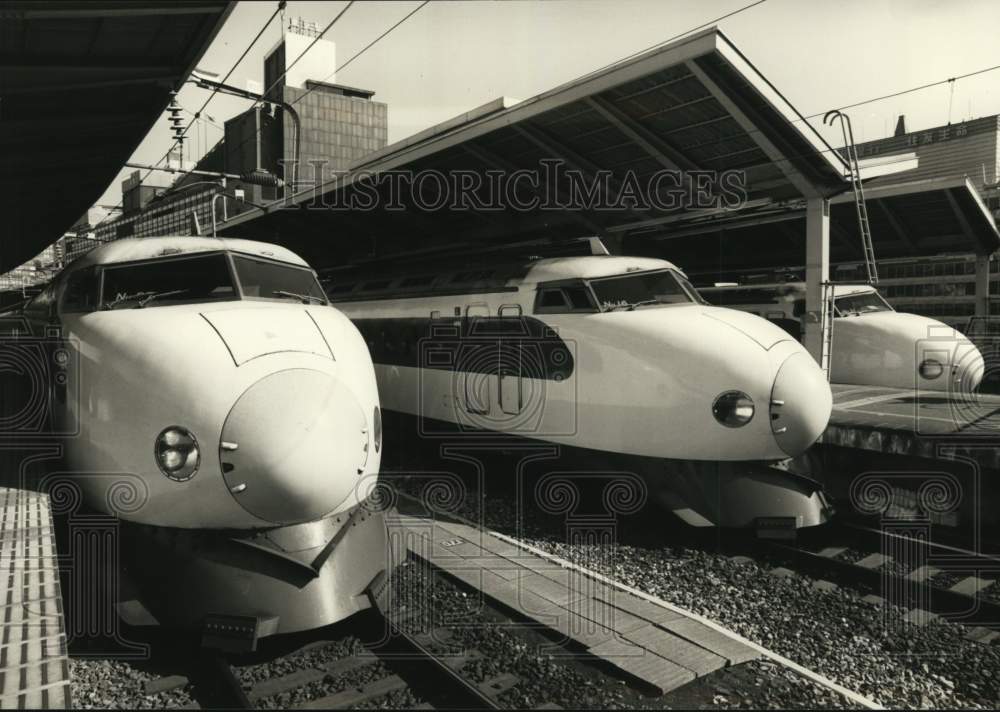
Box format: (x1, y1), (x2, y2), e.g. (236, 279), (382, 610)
(222, 28), (848, 266)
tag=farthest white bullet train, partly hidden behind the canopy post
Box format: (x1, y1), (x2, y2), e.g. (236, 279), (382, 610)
(700, 282), (984, 393)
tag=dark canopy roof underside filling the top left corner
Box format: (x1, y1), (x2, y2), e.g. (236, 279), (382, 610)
(0, 0), (233, 271)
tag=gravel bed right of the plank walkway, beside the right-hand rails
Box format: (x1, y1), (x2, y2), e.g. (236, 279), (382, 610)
(388, 478), (1000, 709)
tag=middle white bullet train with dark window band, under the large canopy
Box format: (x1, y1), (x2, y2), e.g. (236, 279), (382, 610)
(323, 255), (832, 527)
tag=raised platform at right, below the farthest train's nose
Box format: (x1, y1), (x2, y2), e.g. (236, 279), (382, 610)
(821, 383), (1000, 468)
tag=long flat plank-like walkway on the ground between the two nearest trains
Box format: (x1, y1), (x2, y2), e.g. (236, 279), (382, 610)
(389, 516), (758, 694)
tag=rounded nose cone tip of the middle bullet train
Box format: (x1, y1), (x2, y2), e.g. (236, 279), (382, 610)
(770, 352), (833, 457)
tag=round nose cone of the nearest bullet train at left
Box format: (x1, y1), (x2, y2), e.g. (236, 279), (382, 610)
(219, 369), (368, 524)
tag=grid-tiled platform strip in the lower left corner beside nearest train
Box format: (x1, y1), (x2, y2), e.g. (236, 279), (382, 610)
(0, 487), (71, 709)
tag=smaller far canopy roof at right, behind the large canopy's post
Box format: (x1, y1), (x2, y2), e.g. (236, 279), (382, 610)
(624, 174), (1000, 275)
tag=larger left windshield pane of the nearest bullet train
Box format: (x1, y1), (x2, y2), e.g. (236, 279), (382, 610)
(101, 252), (239, 309)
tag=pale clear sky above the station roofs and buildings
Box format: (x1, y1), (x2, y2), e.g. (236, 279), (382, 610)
(90, 0), (1000, 216)
